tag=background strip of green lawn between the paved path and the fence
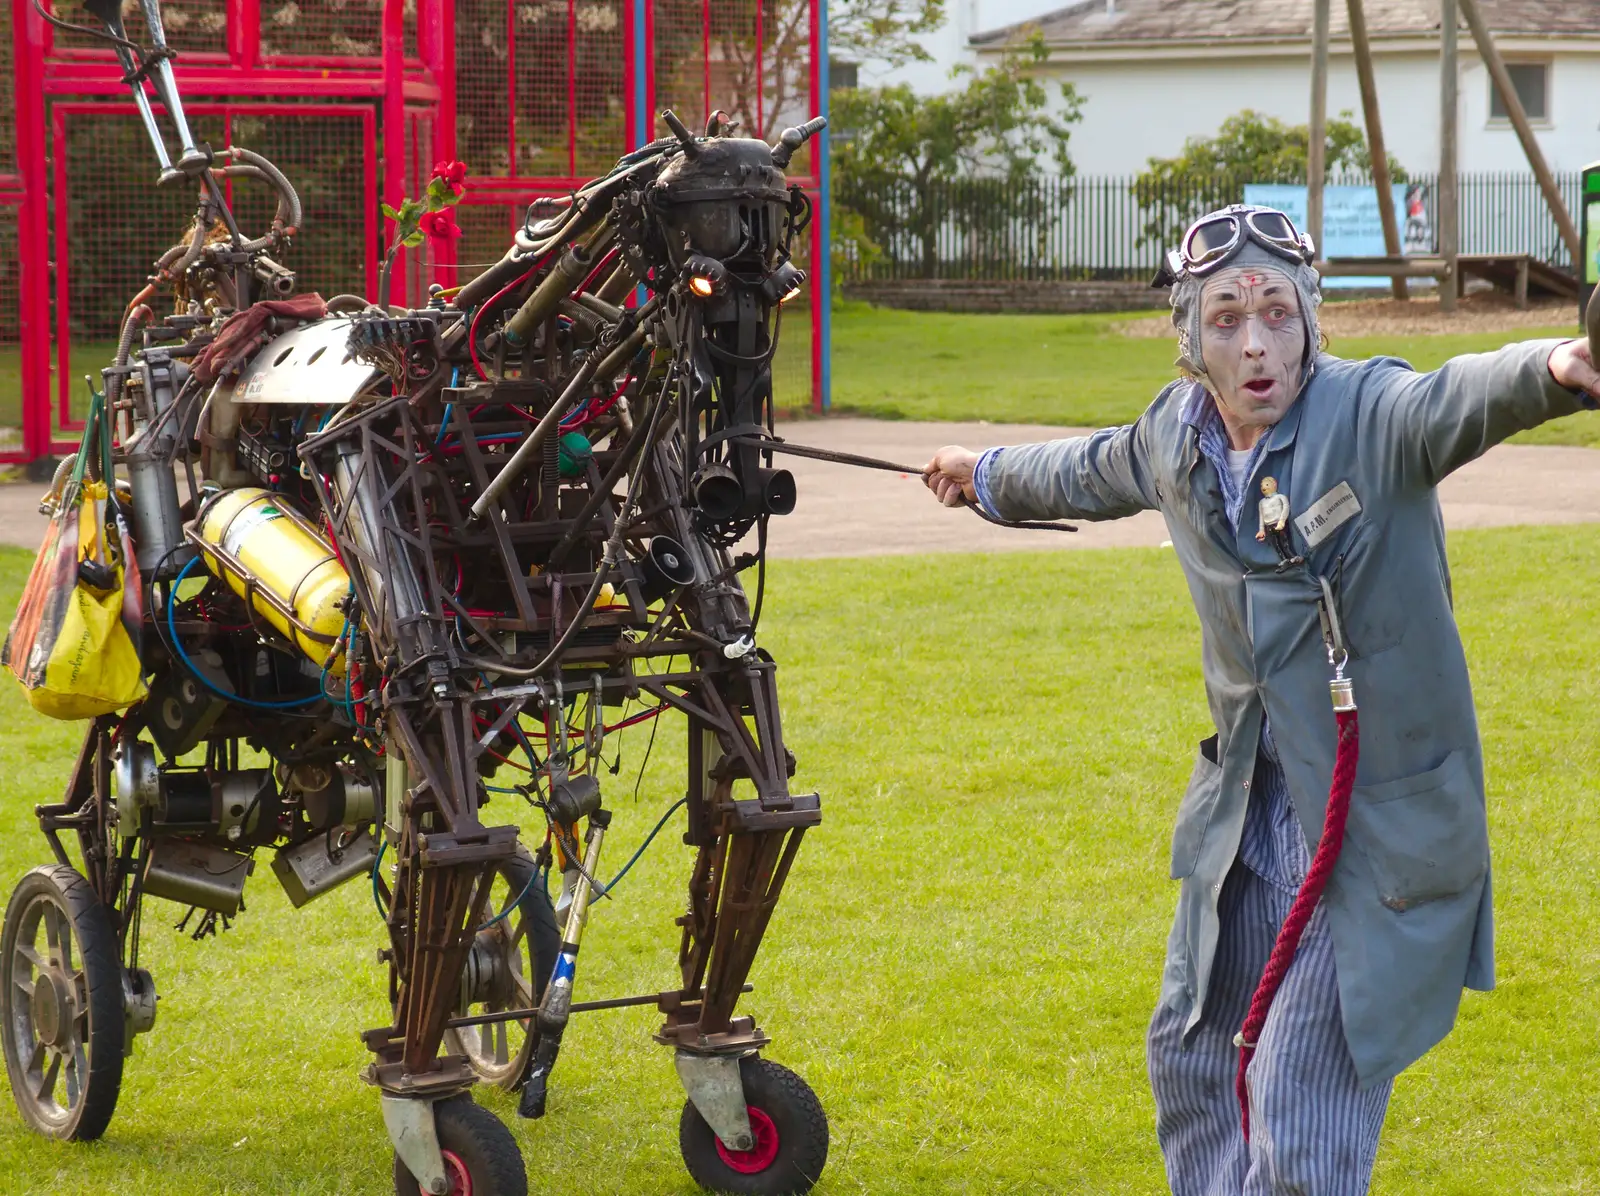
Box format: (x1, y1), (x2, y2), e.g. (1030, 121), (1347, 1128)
(834, 302), (1600, 445)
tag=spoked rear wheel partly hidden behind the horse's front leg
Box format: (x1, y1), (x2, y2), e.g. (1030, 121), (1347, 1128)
(445, 849), (562, 1092)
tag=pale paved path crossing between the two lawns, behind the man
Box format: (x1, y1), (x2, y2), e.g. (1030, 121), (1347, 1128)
(0, 419), (1600, 556)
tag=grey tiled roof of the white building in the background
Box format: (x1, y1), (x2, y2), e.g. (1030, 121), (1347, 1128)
(971, 0), (1600, 48)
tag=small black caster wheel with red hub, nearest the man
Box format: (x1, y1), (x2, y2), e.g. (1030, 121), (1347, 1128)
(678, 1055), (827, 1196)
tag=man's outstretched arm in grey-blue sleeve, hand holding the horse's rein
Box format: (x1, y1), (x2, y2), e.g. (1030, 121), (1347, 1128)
(923, 419), (1157, 520)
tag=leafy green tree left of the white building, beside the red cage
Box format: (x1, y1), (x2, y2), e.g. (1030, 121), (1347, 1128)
(832, 34), (1083, 277)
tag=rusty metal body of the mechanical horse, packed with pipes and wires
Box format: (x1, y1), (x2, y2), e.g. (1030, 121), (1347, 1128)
(12, 16), (826, 1188)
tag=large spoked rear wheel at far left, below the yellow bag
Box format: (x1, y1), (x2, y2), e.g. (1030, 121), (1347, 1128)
(0, 863), (125, 1142)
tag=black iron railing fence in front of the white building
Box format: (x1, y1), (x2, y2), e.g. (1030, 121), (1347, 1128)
(834, 173), (1581, 281)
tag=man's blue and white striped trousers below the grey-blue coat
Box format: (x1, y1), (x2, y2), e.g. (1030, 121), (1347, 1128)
(1146, 863), (1394, 1196)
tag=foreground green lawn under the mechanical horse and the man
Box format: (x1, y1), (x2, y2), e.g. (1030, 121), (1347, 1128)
(0, 528), (1600, 1196)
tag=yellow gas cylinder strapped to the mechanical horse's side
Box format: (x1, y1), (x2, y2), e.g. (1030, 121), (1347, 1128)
(195, 486), (350, 675)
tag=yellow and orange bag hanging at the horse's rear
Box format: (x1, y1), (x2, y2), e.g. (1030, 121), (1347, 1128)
(0, 395), (146, 718)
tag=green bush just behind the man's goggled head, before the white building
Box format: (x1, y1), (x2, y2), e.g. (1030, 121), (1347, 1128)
(1133, 109), (1406, 245)
